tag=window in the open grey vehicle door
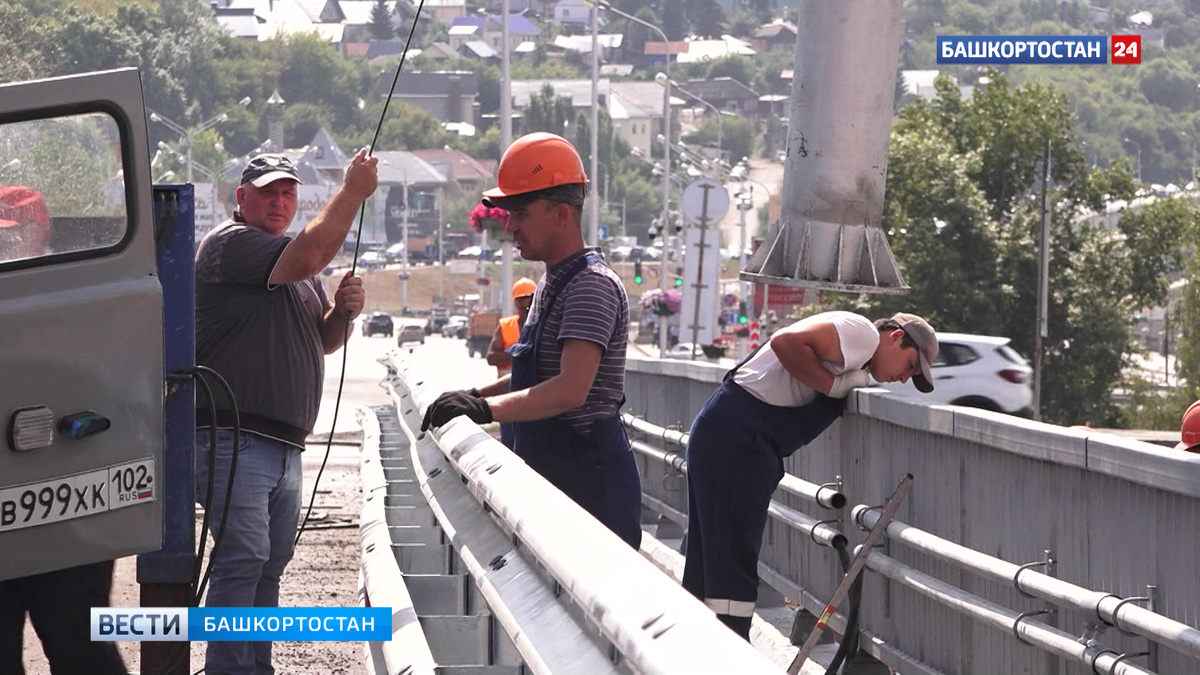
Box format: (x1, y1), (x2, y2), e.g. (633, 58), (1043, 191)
(0, 112), (130, 265)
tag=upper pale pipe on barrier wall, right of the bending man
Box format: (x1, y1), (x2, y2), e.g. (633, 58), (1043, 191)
(851, 504), (1200, 658)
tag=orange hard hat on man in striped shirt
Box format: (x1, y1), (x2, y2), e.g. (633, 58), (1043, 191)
(484, 131), (588, 203)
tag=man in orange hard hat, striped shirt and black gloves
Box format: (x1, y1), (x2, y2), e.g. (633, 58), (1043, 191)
(421, 133), (642, 549)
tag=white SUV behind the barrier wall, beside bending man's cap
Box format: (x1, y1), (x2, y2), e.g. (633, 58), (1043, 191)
(876, 333), (1033, 417)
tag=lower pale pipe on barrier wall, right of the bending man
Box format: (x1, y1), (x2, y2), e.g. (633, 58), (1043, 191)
(854, 546), (1154, 675)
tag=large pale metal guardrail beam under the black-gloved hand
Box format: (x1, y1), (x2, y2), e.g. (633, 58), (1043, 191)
(374, 357), (779, 675)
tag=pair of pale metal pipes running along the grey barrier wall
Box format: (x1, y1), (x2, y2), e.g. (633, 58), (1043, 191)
(623, 414), (1185, 675)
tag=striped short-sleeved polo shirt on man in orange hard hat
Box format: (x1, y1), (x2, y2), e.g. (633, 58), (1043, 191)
(527, 249), (629, 429)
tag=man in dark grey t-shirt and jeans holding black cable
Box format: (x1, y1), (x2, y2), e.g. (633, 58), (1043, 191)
(196, 150), (378, 675)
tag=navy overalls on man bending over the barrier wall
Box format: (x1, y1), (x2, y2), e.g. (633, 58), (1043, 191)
(683, 342), (844, 640)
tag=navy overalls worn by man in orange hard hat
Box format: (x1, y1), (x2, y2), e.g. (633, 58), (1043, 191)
(509, 252), (642, 549)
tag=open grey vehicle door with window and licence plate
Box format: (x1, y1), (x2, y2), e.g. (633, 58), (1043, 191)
(0, 68), (163, 579)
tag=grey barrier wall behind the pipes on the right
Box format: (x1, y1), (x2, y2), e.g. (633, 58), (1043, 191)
(626, 362), (1200, 675)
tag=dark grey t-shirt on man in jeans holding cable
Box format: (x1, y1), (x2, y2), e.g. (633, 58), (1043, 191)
(196, 220), (332, 449)
